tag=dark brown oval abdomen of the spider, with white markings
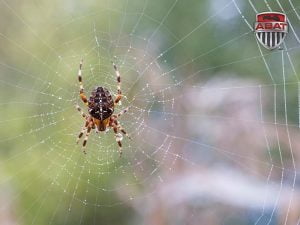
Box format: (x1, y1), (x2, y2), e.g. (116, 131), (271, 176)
(88, 87), (114, 121)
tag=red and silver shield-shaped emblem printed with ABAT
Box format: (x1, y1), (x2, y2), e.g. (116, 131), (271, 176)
(254, 12), (288, 50)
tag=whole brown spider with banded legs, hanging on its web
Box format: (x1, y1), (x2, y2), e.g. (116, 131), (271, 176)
(76, 60), (131, 156)
